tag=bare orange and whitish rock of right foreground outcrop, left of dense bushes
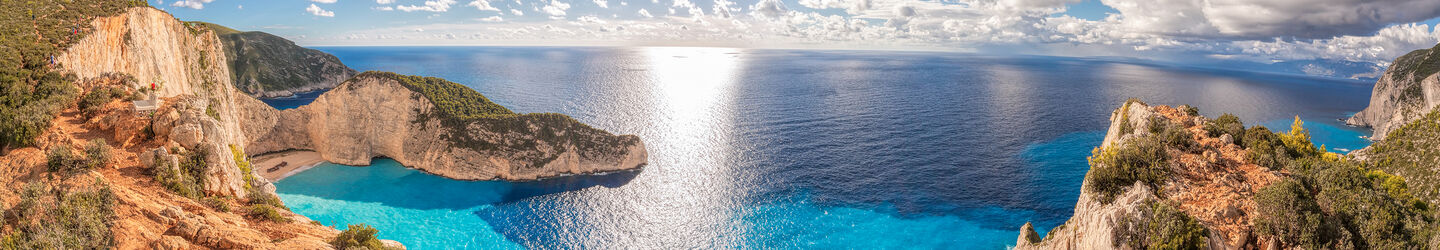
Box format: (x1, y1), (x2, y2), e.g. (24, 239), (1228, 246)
(1015, 101), (1280, 249)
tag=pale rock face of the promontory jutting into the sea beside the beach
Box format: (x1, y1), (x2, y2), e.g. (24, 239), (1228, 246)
(245, 72), (648, 181)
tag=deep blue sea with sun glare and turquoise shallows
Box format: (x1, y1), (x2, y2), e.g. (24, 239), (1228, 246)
(268, 47), (1371, 249)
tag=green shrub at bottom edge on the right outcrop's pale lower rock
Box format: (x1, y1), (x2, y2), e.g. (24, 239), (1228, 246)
(1112, 200), (1210, 250)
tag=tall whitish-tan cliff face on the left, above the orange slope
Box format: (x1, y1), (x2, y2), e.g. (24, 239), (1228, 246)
(56, 7), (266, 197)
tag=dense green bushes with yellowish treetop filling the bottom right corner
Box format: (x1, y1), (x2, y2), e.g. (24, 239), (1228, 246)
(1251, 119), (1437, 249)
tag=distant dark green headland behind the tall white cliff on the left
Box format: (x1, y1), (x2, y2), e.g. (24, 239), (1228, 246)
(203, 23), (356, 98)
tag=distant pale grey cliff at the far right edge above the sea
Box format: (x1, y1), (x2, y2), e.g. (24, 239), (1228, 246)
(1345, 45), (1440, 141)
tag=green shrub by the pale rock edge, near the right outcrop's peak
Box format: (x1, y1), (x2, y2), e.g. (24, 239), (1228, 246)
(1084, 135), (1169, 204)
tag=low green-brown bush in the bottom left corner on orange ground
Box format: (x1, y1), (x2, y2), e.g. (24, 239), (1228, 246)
(0, 180), (115, 249)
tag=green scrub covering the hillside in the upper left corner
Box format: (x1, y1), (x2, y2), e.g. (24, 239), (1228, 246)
(0, 0), (148, 154)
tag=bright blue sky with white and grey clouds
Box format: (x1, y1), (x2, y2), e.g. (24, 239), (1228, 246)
(150, 0), (1440, 78)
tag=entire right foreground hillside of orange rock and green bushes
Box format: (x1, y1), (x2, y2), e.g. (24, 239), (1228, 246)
(1015, 101), (1440, 249)
